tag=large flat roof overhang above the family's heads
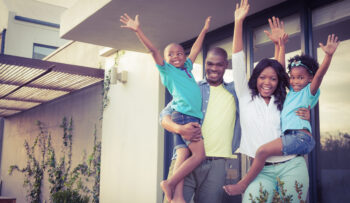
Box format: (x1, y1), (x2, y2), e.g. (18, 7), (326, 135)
(60, 0), (285, 52)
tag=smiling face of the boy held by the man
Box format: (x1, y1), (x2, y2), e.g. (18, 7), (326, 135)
(164, 44), (186, 68)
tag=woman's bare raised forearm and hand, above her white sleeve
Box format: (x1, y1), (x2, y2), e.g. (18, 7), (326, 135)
(232, 0), (249, 54)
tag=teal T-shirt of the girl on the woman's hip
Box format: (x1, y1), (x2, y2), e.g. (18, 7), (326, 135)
(281, 83), (320, 132)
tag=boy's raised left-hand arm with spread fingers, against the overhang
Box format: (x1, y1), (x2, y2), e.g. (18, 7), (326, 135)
(120, 13), (164, 66)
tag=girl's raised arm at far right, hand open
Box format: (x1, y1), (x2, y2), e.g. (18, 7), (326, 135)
(310, 34), (339, 95)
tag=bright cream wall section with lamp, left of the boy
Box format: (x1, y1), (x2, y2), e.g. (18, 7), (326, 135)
(100, 52), (164, 203)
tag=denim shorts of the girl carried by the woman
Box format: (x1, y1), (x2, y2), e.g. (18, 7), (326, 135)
(281, 130), (315, 155)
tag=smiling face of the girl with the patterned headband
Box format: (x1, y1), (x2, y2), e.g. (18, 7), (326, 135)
(289, 66), (312, 92)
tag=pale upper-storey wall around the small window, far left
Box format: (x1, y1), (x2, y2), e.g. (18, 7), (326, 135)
(5, 12), (68, 58)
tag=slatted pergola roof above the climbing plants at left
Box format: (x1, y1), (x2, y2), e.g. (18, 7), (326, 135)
(0, 54), (104, 117)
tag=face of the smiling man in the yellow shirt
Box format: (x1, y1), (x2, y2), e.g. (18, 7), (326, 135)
(205, 52), (228, 86)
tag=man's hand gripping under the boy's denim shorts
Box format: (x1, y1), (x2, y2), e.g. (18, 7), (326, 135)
(177, 122), (202, 142)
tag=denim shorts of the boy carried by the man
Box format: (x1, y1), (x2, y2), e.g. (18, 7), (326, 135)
(171, 111), (200, 150)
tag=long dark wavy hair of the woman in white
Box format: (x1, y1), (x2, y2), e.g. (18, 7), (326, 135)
(248, 58), (289, 111)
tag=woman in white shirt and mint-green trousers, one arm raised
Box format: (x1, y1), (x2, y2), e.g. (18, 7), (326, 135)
(224, 0), (309, 202)
